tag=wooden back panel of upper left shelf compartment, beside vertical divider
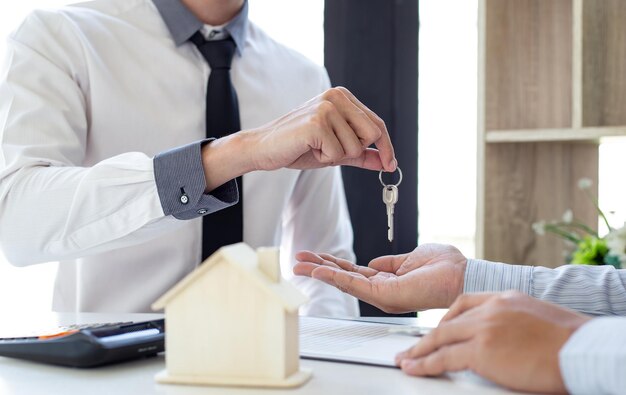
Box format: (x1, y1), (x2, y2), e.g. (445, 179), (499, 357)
(482, 0), (573, 130)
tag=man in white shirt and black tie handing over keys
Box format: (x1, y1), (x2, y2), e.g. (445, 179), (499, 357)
(0, 0), (396, 315)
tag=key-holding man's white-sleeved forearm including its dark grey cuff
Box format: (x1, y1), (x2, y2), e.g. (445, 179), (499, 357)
(0, 142), (238, 265)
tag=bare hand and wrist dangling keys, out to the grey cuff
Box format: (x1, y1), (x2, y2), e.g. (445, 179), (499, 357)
(202, 87), (397, 191)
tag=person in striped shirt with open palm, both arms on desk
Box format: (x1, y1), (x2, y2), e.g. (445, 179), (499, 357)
(294, 244), (626, 394)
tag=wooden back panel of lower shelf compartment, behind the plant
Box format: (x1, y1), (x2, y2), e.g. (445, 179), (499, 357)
(479, 142), (598, 267)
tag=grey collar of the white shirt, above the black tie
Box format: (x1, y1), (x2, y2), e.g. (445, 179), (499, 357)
(152, 0), (248, 56)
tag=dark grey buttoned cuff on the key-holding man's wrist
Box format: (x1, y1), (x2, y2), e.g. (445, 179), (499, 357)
(154, 139), (239, 219)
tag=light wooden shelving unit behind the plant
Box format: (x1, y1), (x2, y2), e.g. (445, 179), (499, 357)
(476, 0), (626, 267)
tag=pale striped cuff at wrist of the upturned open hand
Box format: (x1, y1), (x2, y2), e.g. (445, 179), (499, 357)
(463, 259), (533, 295)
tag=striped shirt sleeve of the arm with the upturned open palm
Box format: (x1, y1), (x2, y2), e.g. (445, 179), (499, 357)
(464, 259), (626, 315)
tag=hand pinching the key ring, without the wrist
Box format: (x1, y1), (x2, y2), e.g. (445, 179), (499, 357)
(252, 87), (397, 172)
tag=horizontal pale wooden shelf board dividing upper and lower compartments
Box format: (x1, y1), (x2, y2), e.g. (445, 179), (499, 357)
(485, 126), (626, 143)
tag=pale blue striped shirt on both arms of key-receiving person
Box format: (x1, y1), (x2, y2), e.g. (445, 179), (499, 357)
(463, 259), (626, 394)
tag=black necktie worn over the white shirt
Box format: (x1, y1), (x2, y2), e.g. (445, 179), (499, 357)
(191, 32), (243, 261)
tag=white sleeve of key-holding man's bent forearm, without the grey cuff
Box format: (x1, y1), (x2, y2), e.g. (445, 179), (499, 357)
(0, 153), (172, 265)
